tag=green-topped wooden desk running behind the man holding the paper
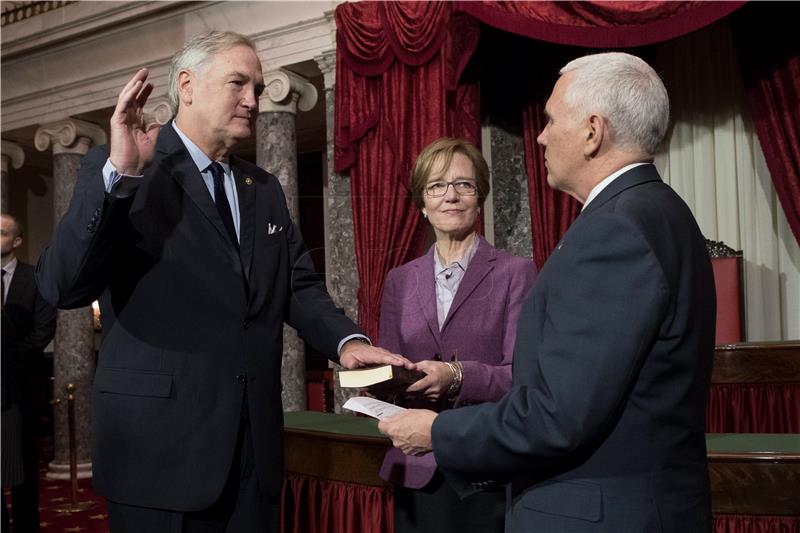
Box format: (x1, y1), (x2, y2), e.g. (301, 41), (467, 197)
(286, 411), (800, 516)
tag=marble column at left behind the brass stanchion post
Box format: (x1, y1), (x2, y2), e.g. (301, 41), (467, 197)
(34, 119), (106, 479)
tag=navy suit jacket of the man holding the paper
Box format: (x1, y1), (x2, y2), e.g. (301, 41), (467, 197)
(433, 165), (715, 533)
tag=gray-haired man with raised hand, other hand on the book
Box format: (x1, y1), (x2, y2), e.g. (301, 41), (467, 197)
(37, 31), (412, 533)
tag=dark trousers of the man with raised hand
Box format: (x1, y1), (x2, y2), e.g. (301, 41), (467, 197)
(108, 406), (280, 533)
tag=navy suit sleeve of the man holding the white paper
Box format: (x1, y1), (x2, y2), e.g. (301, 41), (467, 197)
(432, 215), (668, 482)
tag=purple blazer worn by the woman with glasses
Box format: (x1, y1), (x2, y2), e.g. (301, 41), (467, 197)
(378, 236), (536, 489)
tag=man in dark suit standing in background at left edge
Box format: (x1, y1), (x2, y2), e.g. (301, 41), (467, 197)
(0, 213), (56, 533)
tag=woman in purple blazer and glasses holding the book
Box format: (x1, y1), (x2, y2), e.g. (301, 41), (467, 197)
(379, 138), (536, 533)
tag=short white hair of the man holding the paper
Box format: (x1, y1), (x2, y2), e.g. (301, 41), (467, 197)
(559, 52), (669, 155)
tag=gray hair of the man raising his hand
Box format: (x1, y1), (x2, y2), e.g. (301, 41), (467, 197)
(169, 31), (257, 115)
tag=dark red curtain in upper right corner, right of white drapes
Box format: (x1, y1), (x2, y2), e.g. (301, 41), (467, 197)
(732, 3), (800, 242)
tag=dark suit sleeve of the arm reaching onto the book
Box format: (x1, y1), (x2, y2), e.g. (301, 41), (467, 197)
(284, 212), (363, 361)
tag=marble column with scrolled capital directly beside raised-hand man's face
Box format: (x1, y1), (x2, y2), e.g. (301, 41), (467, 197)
(256, 70), (317, 411)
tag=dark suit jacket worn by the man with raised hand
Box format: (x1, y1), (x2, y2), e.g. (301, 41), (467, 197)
(38, 126), (360, 512)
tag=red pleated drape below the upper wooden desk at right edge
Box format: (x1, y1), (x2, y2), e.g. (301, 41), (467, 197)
(706, 383), (800, 433)
